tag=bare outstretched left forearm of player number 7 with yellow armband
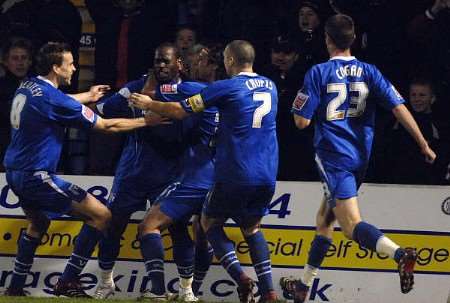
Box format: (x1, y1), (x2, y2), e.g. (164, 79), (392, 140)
(129, 93), (189, 120)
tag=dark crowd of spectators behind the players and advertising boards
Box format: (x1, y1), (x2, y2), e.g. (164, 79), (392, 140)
(0, 0), (450, 184)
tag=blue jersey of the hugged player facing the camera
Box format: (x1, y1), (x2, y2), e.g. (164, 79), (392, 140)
(97, 76), (209, 188)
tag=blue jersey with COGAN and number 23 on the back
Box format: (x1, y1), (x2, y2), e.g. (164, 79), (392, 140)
(292, 57), (404, 170)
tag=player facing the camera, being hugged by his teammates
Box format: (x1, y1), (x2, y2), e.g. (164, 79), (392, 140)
(55, 43), (207, 299)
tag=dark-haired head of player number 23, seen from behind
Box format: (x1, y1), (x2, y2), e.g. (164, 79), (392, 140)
(325, 14), (355, 49)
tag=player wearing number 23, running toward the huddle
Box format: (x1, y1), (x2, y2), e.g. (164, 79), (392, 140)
(280, 15), (436, 303)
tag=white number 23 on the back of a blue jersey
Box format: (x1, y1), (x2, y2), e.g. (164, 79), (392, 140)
(327, 82), (369, 121)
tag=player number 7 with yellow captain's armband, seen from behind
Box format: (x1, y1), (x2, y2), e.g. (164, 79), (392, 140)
(130, 40), (278, 302)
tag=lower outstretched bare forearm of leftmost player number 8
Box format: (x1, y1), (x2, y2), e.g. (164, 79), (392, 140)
(94, 114), (154, 133)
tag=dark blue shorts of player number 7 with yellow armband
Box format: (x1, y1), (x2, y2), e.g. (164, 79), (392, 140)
(203, 183), (275, 222)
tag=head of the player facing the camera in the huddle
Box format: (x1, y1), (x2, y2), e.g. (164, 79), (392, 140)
(153, 47), (181, 83)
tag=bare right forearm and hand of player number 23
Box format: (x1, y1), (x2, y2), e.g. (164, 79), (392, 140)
(392, 104), (436, 163)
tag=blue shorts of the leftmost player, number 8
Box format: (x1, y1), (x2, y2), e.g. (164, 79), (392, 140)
(6, 170), (87, 217)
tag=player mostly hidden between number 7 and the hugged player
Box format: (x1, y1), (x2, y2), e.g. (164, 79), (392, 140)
(127, 44), (219, 302)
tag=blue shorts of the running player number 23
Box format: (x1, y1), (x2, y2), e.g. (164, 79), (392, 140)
(316, 155), (366, 208)
